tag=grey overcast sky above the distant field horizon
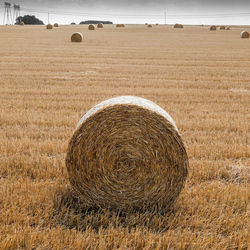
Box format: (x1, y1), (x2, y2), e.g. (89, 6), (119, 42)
(0, 0), (250, 24)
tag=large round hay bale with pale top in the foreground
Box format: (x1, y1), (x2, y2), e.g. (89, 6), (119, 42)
(66, 96), (188, 210)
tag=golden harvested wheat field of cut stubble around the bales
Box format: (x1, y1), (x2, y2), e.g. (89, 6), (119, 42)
(0, 25), (250, 249)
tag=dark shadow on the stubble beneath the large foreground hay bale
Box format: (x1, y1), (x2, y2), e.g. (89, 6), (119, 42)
(50, 188), (178, 233)
